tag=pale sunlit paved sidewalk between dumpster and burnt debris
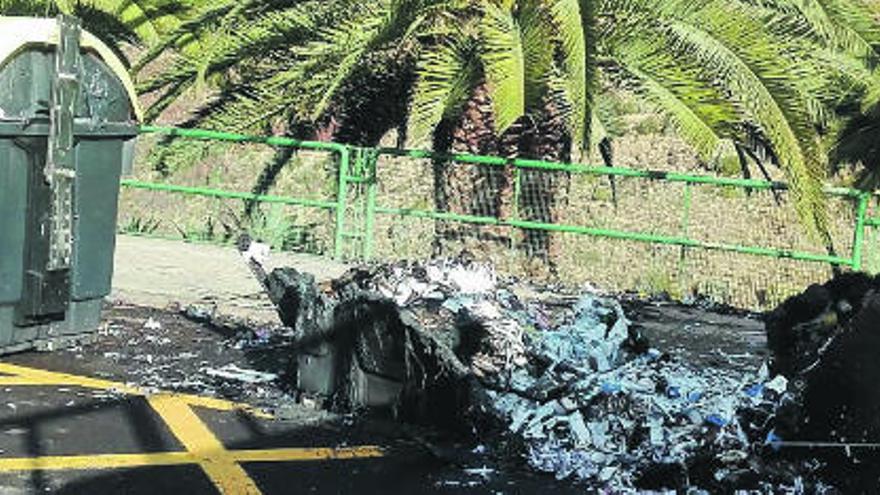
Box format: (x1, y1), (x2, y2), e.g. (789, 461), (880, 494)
(111, 235), (346, 322)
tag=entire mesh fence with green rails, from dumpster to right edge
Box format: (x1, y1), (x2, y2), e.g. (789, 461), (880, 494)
(127, 129), (880, 310)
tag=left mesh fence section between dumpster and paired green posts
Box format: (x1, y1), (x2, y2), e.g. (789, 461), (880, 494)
(119, 130), (339, 255)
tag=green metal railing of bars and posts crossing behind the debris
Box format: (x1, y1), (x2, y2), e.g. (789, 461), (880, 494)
(123, 126), (880, 286)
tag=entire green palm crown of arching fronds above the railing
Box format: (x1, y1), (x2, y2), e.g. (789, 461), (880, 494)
(143, 0), (878, 252)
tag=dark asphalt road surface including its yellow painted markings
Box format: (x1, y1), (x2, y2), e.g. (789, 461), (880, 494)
(0, 305), (582, 495)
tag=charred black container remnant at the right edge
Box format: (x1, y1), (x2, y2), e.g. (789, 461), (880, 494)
(766, 273), (880, 493)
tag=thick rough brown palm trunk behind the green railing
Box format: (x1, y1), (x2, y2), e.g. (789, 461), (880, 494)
(434, 83), (571, 269)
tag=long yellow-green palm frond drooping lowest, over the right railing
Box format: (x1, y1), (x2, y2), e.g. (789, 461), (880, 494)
(609, 0), (827, 235)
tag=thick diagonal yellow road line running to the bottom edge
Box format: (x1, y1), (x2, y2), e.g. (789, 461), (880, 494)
(148, 395), (260, 495)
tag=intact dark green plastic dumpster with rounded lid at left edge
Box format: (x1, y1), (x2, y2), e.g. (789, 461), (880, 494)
(0, 17), (140, 354)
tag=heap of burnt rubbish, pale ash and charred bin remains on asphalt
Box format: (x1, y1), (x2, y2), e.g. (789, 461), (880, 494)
(264, 260), (880, 491)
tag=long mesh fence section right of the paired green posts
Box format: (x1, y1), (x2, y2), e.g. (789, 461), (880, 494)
(366, 150), (880, 309)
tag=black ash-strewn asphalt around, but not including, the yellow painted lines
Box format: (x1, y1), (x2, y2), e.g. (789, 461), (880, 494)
(0, 303), (582, 495)
